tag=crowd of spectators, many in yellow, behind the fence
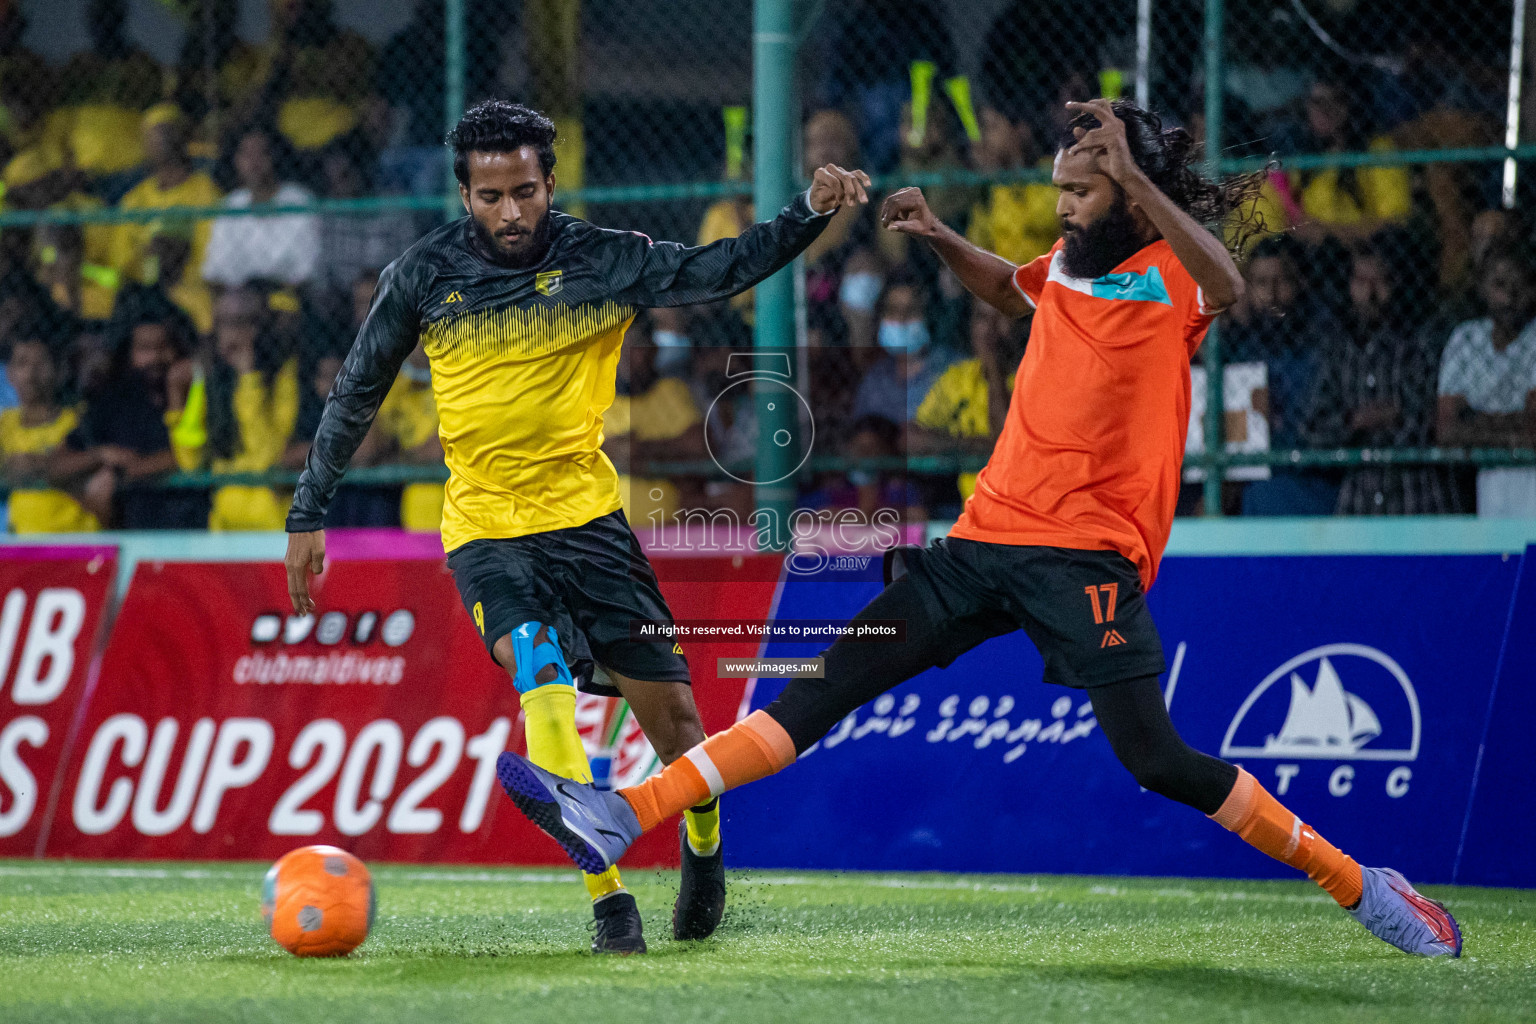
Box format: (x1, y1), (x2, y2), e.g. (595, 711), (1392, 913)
(0, 0), (1536, 531)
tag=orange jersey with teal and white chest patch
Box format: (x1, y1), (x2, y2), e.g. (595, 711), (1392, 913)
(949, 239), (1212, 586)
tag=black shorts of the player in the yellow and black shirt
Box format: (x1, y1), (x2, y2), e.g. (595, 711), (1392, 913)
(449, 511), (690, 697)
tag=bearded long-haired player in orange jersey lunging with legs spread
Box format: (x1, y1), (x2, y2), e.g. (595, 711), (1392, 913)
(498, 100), (1461, 956)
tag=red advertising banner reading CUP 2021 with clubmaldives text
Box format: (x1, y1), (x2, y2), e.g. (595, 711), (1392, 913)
(46, 559), (774, 866)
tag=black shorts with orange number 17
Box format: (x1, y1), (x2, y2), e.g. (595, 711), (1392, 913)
(886, 537), (1167, 689)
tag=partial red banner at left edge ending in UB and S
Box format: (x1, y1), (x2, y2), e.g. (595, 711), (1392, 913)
(0, 545), (117, 857)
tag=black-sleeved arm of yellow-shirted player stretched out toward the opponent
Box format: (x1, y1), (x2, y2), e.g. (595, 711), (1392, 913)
(613, 164), (869, 307)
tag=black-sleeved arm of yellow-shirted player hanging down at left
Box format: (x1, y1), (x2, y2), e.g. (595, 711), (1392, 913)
(284, 261), (421, 616)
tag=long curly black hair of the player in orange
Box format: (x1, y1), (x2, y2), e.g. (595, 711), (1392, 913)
(1057, 100), (1270, 256)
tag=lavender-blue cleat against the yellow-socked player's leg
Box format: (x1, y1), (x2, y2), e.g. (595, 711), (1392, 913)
(496, 752), (641, 875)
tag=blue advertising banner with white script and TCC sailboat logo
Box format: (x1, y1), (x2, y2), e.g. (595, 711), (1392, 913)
(725, 554), (1536, 884)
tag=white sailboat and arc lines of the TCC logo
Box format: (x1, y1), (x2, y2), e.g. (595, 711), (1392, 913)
(1221, 643), (1419, 761)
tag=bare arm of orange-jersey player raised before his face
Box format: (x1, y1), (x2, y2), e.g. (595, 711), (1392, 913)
(1066, 100), (1243, 313)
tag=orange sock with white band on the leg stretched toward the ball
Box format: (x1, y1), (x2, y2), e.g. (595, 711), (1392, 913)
(619, 711), (794, 832)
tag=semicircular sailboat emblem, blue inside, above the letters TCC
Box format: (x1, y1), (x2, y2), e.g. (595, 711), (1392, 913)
(1221, 643), (1422, 761)
